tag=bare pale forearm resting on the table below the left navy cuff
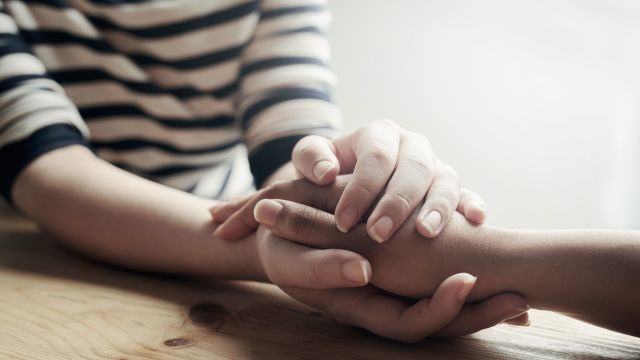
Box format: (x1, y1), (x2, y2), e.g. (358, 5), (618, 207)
(13, 146), (265, 280)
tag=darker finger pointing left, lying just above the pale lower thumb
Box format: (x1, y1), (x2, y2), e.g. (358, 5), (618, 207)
(255, 199), (366, 248)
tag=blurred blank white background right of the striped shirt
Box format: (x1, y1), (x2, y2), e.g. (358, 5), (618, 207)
(330, 0), (640, 229)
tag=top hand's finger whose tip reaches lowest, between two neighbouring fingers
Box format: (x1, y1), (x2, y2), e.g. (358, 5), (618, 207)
(367, 134), (434, 243)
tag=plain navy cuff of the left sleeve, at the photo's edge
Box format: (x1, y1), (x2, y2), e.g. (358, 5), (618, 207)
(0, 124), (90, 204)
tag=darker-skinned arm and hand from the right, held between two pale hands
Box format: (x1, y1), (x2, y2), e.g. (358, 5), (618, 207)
(249, 179), (640, 336)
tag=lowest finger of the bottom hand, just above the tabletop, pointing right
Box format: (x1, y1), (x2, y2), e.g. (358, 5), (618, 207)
(433, 293), (529, 337)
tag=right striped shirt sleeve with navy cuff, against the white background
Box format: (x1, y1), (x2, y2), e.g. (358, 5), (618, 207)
(236, 0), (341, 186)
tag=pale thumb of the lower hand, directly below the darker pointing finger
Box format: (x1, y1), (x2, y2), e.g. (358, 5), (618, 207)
(257, 228), (371, 289)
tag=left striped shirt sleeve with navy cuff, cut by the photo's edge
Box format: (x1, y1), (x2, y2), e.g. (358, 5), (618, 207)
(0, 5), (89, 202)
